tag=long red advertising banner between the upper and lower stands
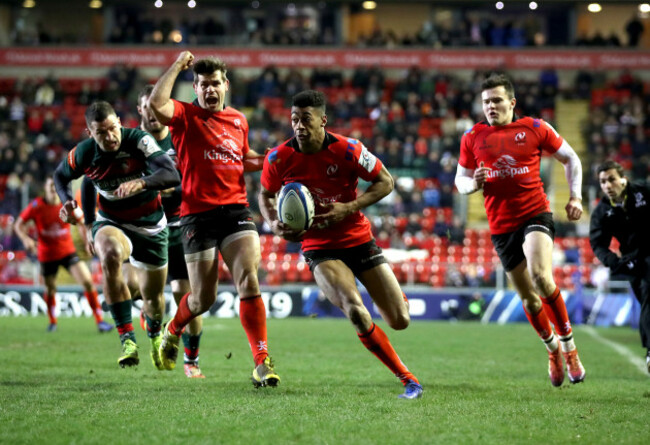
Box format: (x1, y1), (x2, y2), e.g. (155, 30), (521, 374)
(0, 47), (650, 70)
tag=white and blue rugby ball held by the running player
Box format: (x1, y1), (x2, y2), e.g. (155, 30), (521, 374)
(277, 182), (314, 230)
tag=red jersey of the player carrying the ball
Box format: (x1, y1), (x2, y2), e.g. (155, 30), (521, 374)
(262, 133), (383, 251)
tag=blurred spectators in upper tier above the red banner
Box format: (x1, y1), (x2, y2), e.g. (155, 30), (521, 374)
(9, 2), (645, 48)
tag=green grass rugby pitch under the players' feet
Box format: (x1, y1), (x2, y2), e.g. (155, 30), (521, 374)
(0, 317), (650, 445)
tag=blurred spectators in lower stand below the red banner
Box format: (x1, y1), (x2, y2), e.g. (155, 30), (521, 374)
(0, 65), (650, 285)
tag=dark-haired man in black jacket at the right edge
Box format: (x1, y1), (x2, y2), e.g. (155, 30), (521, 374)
(589, 161), (650, 372)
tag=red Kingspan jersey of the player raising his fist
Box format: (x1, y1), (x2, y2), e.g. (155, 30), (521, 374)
(169, 99), (249, 216)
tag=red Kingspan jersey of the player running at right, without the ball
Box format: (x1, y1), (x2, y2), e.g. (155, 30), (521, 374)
(458, 117), (563, 235)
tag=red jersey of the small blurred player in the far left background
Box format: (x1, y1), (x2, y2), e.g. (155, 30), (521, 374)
(20, 198), (77, 263)
